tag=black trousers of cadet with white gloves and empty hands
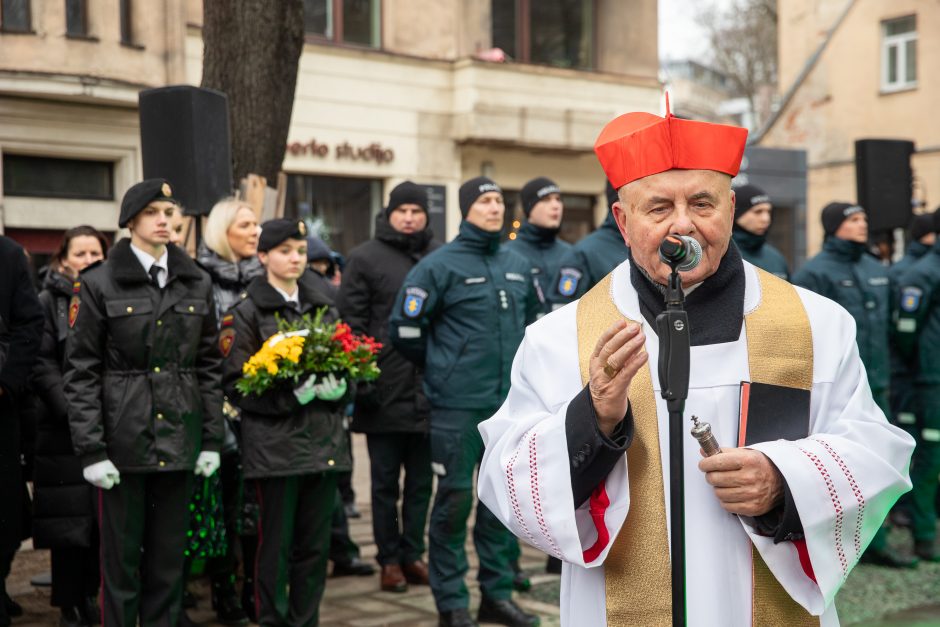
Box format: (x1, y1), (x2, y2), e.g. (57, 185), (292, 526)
(98, 471), (193, 627)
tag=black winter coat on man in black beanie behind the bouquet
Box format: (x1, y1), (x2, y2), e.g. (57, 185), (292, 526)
(337, 214), (440, 433)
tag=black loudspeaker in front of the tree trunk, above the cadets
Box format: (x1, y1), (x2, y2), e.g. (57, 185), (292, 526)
(139, 85), (233, 216)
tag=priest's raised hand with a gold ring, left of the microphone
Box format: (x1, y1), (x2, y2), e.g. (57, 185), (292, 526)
(588, 320), (648, 436)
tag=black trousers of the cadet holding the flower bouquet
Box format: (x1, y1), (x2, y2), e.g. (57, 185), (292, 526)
(254, 473), (337, 627)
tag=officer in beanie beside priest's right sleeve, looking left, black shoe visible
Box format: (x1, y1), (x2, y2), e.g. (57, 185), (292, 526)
(793, 202), (917, 568)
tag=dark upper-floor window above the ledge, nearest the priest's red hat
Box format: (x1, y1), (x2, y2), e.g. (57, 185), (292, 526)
(490, 0), (595, 69)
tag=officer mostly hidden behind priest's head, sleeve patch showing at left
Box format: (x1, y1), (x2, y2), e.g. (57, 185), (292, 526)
(548, 182), (629, 309)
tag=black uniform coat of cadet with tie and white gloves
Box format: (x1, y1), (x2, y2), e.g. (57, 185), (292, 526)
(65, 239), (223, 472)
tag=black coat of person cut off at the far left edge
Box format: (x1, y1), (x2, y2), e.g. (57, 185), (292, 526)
(0, 236), (42, 553)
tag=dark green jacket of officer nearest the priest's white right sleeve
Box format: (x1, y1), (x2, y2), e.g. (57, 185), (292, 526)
(793, 237), (892, 413)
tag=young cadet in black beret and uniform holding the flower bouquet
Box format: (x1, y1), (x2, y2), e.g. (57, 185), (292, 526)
(220, 219), (351, 627)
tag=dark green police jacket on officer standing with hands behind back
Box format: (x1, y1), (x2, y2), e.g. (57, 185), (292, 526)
(389, 221), (539, 409)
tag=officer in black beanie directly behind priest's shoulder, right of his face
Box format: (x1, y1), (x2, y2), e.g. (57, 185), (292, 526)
(731, 185), (790, 280)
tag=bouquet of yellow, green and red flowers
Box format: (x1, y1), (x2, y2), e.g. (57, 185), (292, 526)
(235, 307), (382, 396)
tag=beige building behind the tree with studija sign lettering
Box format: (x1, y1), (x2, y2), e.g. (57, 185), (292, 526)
(0, 0), (660, 254)
